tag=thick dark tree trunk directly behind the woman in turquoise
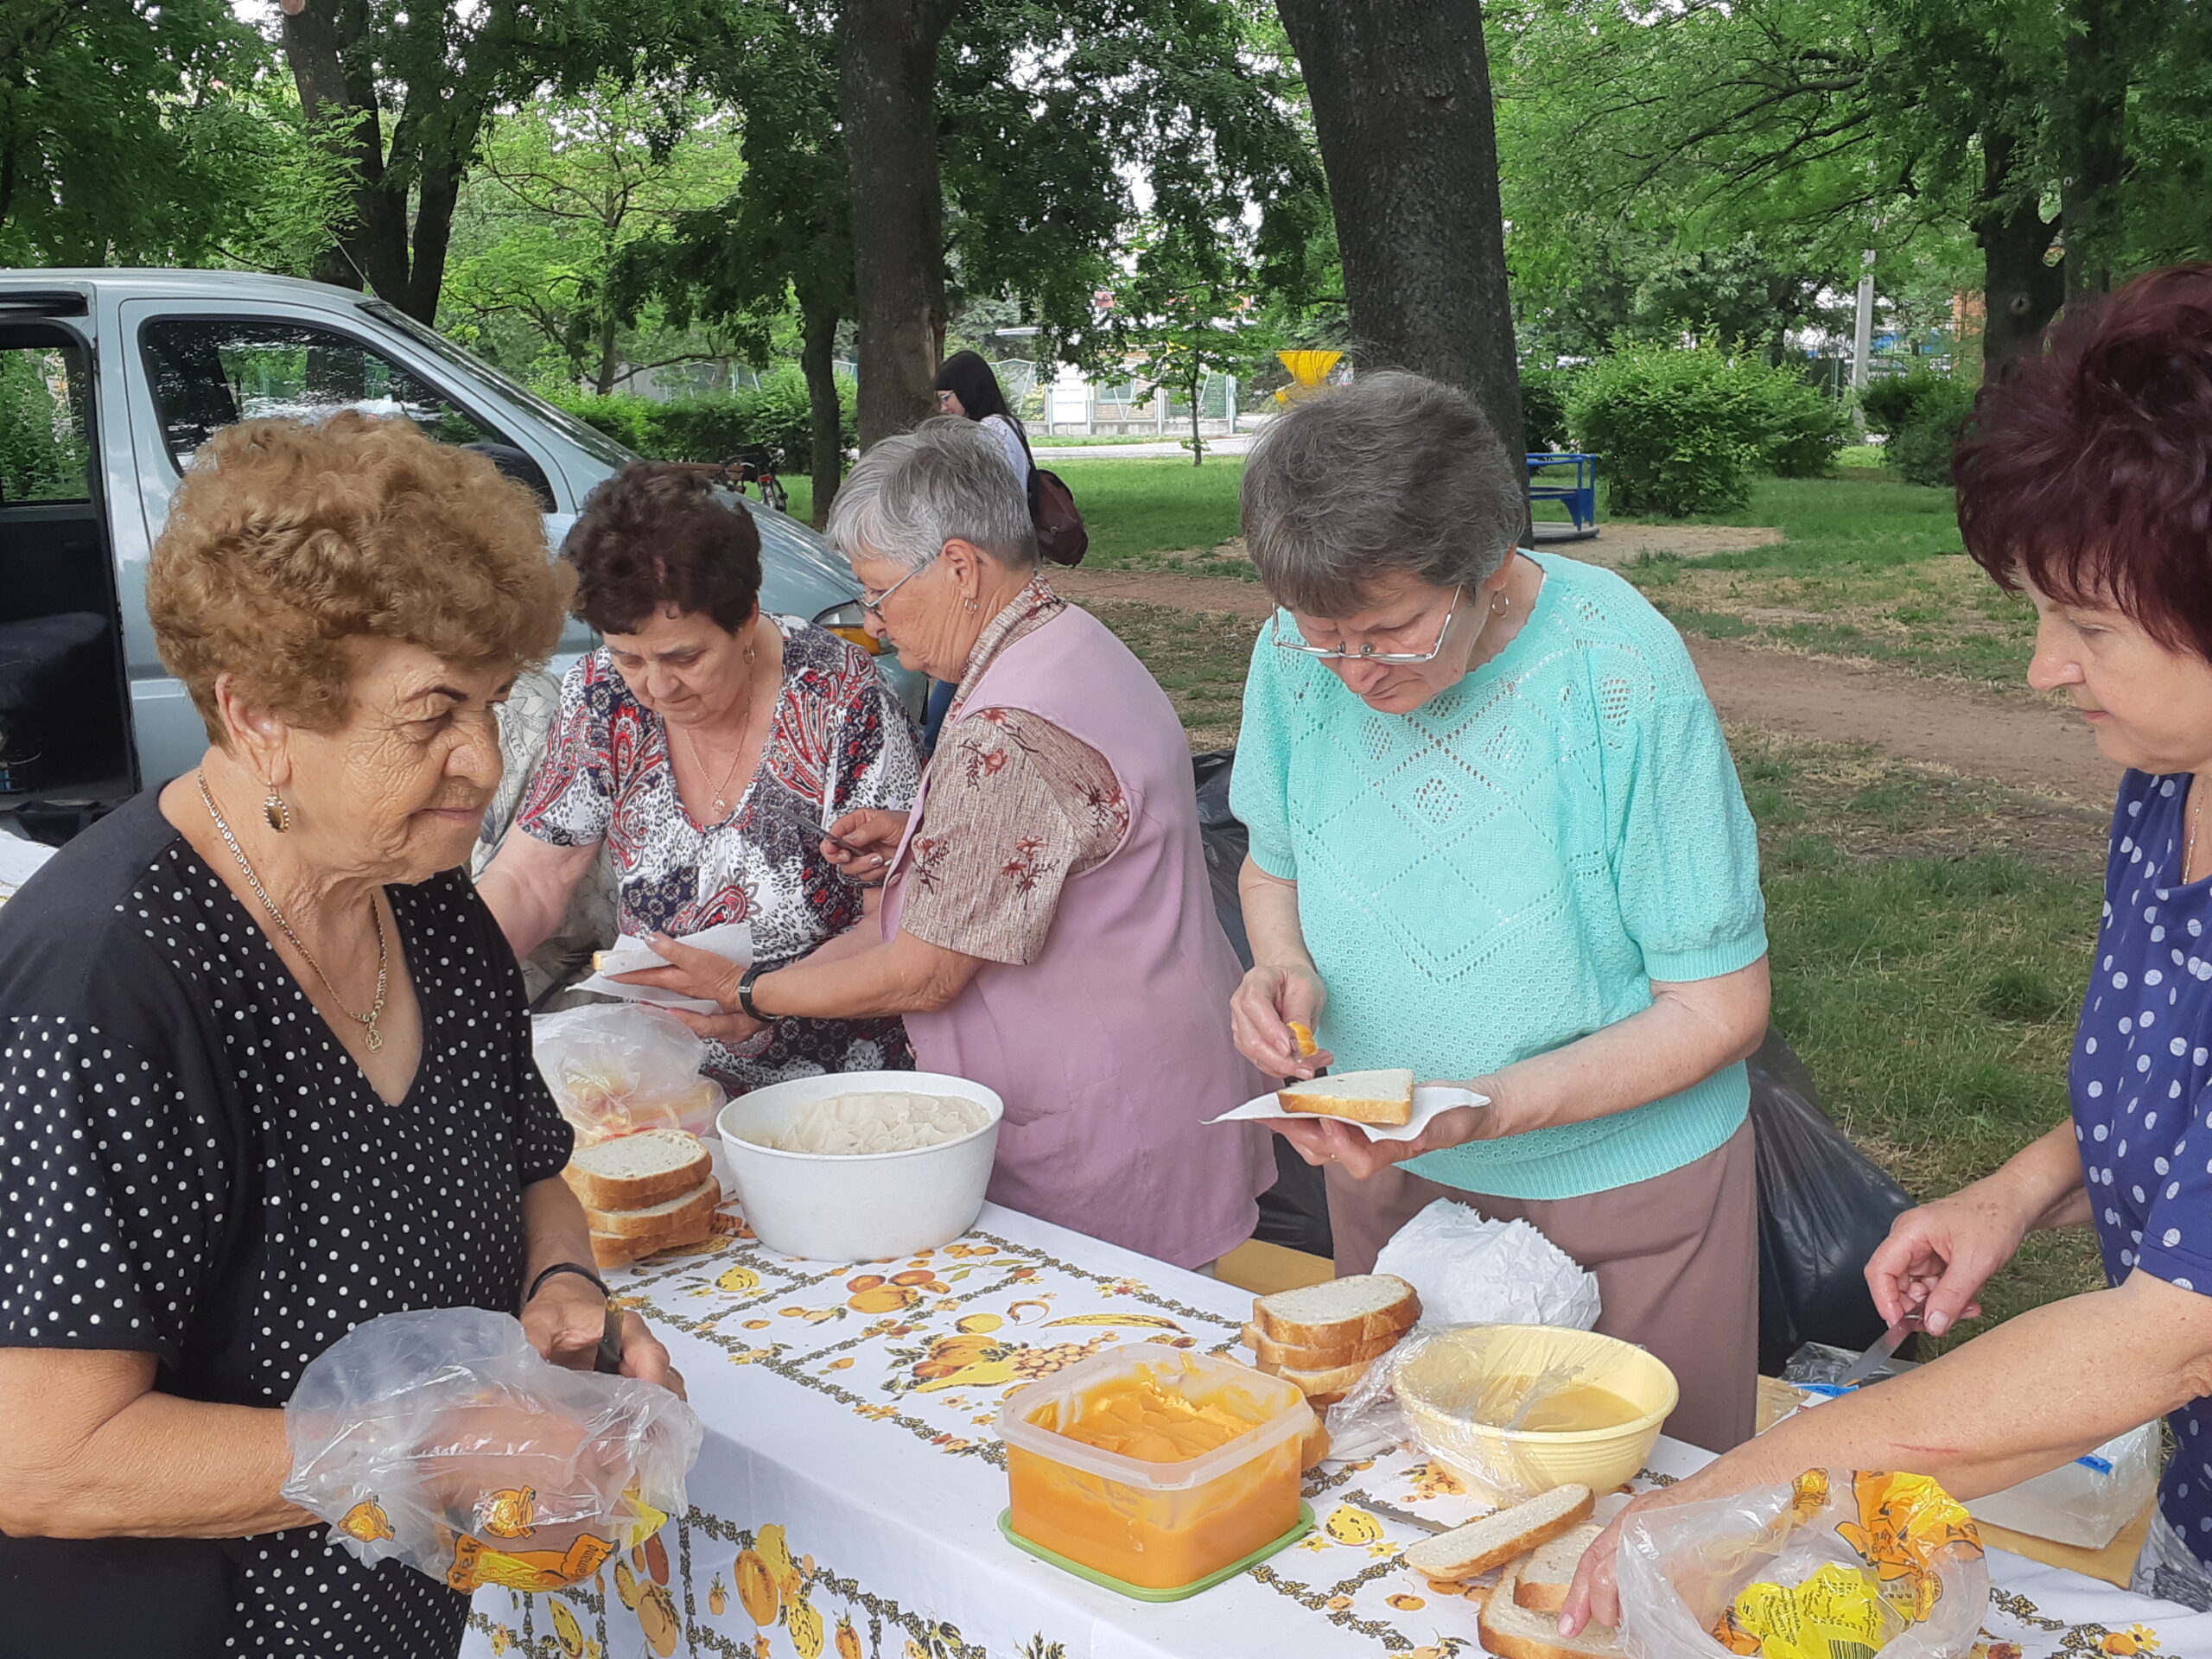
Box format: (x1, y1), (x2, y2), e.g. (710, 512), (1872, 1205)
(1276, 0), (1522, 451)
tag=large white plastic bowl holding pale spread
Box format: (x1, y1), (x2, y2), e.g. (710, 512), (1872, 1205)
(716, 1071), (1007, 1261)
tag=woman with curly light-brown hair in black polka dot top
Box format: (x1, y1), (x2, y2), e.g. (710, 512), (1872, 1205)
(0, 414), (671, 1659)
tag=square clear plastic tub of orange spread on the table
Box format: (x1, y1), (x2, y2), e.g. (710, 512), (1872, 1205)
(998, 1343), (1314, 1599)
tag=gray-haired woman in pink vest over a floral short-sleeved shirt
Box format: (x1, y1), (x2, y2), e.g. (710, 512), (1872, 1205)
(631, 418), (1274, 1268)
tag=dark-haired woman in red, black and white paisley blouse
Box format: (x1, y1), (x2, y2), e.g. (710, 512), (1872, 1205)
(478, 462), (918, 1093)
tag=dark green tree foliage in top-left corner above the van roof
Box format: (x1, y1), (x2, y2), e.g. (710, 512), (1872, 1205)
(0, 0), (345, 270)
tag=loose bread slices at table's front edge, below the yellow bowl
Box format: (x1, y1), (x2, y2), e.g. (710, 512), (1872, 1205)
(1398, 1486), (1628, 1659)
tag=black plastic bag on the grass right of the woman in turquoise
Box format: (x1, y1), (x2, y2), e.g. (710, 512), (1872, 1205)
(1750, 1031), (1913, 1376)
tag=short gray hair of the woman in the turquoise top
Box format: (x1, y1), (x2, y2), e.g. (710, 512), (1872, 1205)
(1243, 372), (1529, 617)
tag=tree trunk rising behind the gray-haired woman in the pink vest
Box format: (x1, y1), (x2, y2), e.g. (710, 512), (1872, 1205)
(838, 0), (957, 449)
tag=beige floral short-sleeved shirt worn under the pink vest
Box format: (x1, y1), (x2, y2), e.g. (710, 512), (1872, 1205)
(898, 575), (1128, 963)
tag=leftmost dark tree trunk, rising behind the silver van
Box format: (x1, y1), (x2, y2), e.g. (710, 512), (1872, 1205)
(283, 0), (407, 298)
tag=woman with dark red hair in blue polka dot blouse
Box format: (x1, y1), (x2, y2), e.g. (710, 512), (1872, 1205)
(1561, 265), (2212, 1628)
